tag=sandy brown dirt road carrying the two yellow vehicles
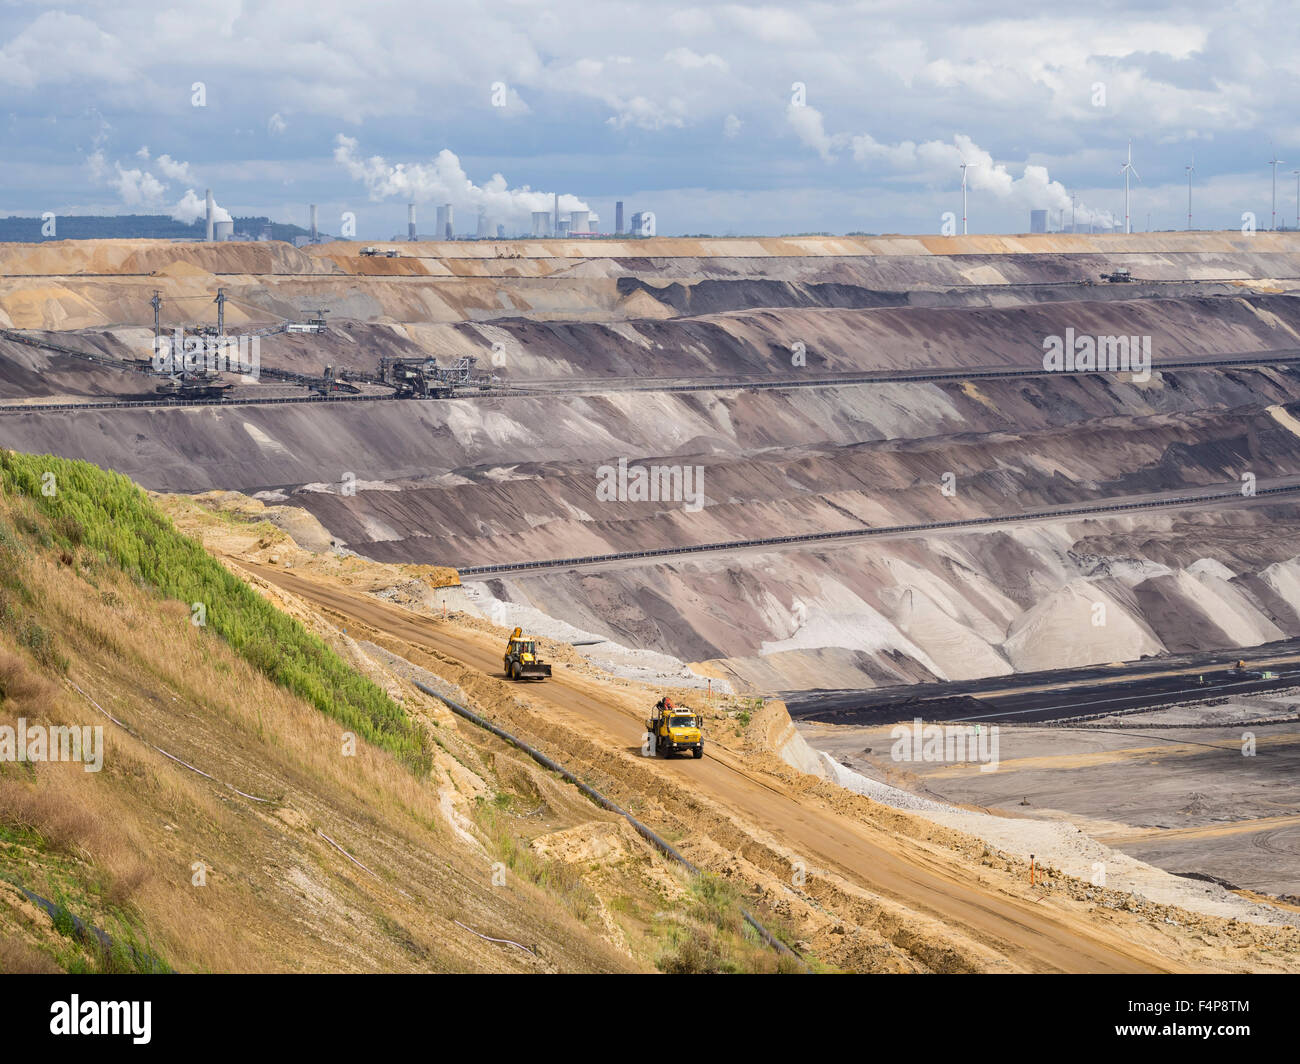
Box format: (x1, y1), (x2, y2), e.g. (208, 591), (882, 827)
(234, 559), (1179, 972)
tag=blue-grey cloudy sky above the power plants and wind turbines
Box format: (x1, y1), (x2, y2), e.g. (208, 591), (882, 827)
(0, 0), (1300, 239)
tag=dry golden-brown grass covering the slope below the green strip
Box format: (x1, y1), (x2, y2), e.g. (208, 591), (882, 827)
(0, 476), (641, 972)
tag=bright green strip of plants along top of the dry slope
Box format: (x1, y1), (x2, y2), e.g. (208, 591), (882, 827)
(0, 451), (432, 774)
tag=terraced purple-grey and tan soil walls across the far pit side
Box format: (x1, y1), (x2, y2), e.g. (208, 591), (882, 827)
(0, 234), (1300, 691)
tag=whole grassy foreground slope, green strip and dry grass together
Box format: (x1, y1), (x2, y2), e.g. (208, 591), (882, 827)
(0, 453), (776, 972)
